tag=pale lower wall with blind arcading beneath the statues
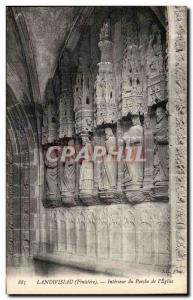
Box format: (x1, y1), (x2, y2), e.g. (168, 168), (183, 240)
(41, 203), (170, 268)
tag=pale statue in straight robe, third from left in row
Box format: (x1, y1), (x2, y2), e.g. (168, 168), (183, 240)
(79, 135), (94, 199)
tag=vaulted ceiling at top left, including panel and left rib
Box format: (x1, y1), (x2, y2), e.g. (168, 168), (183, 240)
(7, 7), (82, 102)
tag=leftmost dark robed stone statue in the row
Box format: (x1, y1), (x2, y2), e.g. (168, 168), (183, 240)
(45, 149), (59, 200)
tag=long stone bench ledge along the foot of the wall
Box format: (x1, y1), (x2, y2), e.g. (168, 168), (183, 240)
(34, 254), (163, 277)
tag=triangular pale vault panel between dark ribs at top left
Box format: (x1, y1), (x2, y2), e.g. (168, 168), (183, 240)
(21, 7), (80, 95)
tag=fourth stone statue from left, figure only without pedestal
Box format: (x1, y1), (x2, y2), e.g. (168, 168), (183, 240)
(99, 127), (117, 191)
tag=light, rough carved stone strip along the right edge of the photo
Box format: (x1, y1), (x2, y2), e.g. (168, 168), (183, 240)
(172, 6), (187, 272)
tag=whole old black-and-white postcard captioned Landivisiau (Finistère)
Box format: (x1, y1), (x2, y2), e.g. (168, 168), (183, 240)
(6, 6), (188, 294)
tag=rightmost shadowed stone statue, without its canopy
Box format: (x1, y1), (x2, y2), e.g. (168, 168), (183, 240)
(153, 107), (169, 186)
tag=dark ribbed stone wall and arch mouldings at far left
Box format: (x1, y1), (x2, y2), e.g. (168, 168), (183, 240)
(6, 8), (42, 267)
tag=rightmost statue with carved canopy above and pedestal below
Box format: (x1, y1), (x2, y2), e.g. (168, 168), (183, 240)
(144, 23), (169, 201)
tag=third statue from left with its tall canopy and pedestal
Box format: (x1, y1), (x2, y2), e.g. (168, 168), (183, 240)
(74, 28), (95, 205)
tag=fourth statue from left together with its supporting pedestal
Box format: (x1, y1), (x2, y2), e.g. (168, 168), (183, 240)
(99, 127), (117, 202)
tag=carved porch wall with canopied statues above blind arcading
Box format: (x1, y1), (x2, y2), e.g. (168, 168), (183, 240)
(40, 8), (171, 269)
